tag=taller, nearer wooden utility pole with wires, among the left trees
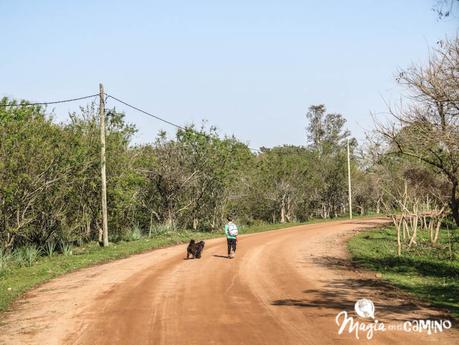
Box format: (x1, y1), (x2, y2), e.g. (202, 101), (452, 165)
(99, 83), (108, 247)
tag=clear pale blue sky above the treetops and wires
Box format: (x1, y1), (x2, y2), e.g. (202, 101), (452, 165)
(0, 0), (459, 147)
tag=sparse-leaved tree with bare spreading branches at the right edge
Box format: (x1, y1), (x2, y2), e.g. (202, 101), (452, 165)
(378, 38), (459, 225)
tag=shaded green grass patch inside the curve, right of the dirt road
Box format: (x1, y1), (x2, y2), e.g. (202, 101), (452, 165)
(348, 227), (459, 317)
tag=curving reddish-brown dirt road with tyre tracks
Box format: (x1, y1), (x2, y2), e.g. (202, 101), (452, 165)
(0, 219), (459, 345)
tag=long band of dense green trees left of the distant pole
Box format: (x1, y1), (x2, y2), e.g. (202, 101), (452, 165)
(0, 98), (357, 248)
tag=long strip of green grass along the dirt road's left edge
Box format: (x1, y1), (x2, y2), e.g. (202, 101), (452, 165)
(0, 223), (310, 311)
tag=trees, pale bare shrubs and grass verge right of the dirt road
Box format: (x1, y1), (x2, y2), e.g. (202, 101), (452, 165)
(348, 38), (459, 317)
